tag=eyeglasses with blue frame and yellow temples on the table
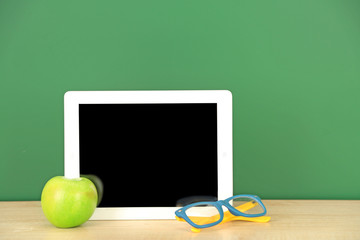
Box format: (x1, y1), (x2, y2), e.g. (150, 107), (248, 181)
(175, 194), (270, 232)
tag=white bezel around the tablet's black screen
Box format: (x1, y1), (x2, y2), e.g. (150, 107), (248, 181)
(64, 90), (233, 220)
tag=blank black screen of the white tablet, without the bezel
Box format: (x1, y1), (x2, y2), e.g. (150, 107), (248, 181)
(79, 103), (218, 207)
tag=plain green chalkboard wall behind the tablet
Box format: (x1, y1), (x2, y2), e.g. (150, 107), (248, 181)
(0, 0), (360, 200)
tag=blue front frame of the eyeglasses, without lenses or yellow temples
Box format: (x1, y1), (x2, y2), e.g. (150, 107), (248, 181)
(175, 194), (267, 228)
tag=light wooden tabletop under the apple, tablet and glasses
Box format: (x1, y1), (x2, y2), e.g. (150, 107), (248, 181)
(0, 200), (360, 240)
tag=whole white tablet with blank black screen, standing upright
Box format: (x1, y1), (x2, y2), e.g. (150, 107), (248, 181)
(64, 90), (233, 220)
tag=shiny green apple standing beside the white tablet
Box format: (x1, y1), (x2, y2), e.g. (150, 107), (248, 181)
(41, 176), (98, 228)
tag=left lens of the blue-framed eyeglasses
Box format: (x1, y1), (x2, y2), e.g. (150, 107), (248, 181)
(185, 205), (220, 225)
